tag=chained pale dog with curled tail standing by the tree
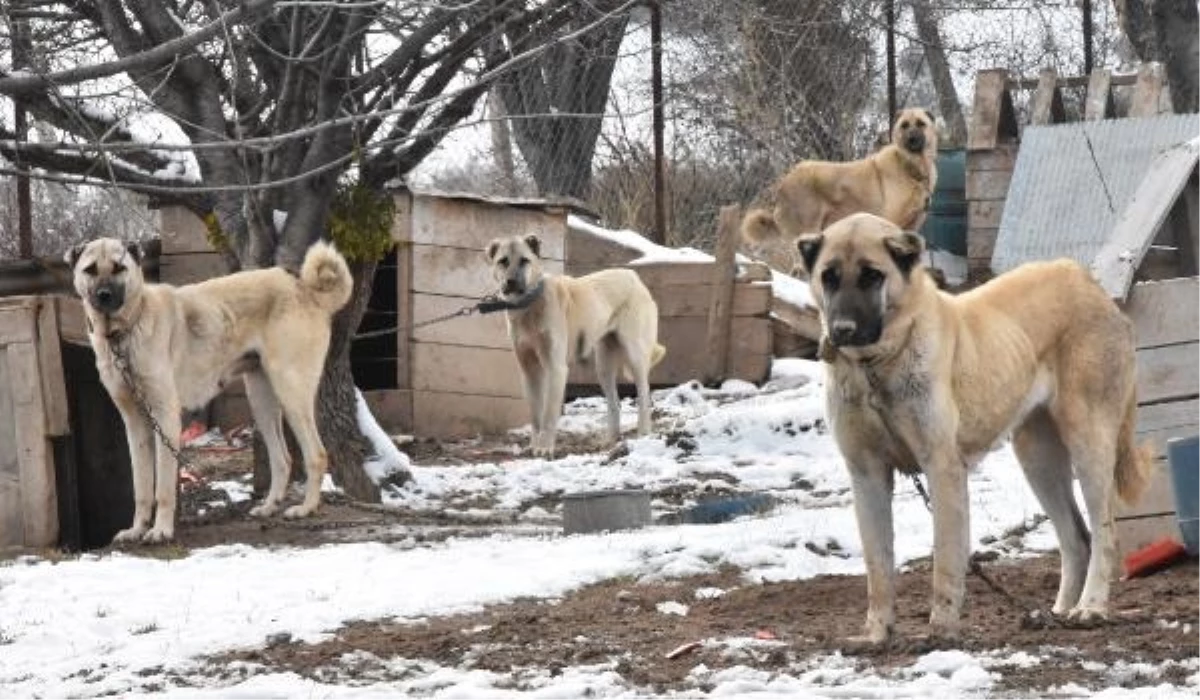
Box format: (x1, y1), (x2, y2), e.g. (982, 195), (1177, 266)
(65, 238), (352, 543)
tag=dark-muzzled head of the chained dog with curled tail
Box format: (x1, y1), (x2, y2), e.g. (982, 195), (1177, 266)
(62, 238), (144, 316)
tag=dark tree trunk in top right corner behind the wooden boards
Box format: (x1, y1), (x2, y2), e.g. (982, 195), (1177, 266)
(1114, 0), (1200, 113)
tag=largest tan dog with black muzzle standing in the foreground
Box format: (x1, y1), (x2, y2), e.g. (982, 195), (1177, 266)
(798, 214), (1151, 641)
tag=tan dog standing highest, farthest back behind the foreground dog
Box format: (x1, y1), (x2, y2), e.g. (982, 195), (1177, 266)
(742, 108), (937, 252)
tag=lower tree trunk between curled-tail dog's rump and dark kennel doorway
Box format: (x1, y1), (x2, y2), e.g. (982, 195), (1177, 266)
(317, 262), (379, 503)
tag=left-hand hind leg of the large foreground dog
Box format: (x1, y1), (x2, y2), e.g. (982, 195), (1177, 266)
(1013, 411), (1090, 615)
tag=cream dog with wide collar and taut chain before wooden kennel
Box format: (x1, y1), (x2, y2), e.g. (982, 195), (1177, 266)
(486, 235), (666, 456)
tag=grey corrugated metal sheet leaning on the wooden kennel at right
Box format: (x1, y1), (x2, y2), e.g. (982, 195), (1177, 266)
(991, 114), (1200, 273)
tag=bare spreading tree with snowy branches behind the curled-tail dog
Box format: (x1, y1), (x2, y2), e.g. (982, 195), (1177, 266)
(0, 0), (628, 499)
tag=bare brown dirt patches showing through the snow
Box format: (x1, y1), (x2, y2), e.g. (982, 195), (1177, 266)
(157, 444), (1200, 696)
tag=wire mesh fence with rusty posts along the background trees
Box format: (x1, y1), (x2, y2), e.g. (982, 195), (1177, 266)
(0, 0), (1135, 258)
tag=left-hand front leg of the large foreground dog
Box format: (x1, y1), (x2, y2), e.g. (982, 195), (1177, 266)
(847, 457), (895, 644)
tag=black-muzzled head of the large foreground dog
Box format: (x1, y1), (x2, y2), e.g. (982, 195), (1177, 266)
(797, 214), (931, 348)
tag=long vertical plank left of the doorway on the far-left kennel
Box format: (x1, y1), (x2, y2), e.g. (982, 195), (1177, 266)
(6, 342), (59, 548)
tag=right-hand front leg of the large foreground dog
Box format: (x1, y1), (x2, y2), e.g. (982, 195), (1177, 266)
(923, 446), (971, 635)
